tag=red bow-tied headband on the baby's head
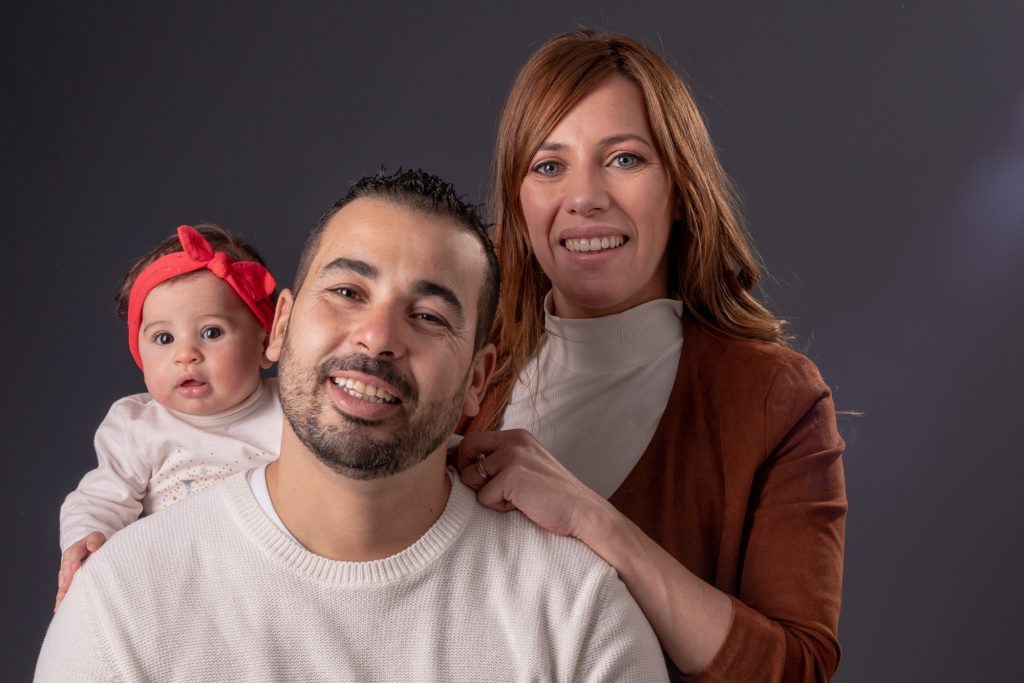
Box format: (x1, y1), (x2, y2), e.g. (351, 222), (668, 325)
(128, 225), (278, 370)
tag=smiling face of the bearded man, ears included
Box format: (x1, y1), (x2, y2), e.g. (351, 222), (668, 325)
(267, 198), (494, 479)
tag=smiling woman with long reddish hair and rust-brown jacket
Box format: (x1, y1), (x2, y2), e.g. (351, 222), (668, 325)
(460, 31), (847, 681)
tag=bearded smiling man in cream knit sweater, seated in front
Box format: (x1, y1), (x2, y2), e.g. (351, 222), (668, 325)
(36, 167), (666, 681)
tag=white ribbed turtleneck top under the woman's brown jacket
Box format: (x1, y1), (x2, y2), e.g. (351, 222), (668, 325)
(502, 293), (683, 498)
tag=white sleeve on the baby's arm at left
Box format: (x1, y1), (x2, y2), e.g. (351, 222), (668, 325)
(60, 397), (153, 552)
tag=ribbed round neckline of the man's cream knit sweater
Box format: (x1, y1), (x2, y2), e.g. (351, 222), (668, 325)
(220, 469), (478, 588)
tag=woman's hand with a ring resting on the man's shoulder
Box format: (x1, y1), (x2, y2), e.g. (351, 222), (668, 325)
(459, 429), (610, 540)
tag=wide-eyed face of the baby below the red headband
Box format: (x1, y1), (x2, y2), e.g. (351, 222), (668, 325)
(138, 271), (269, 415)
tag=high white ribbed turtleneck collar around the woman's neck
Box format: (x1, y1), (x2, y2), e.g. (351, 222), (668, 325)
(543, 292), (683, 374)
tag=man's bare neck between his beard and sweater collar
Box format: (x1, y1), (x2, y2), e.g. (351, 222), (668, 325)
(266, 426), (452, 562)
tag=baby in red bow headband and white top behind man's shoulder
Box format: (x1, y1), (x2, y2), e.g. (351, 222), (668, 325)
(54, 225), (283, 609)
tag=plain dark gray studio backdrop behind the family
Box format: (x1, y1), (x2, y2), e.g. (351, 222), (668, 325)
(0, 0), (1024, 681)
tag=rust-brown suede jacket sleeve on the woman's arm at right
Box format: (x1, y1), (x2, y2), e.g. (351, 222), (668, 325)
(692, 357), (847, 682)
